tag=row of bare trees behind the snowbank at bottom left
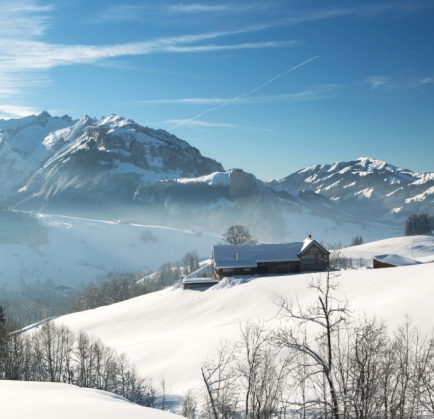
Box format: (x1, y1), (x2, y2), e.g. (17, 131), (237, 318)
(0, 322), (156, 406)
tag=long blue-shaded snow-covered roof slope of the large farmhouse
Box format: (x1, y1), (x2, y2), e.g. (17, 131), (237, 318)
(213, 242), (304, 268)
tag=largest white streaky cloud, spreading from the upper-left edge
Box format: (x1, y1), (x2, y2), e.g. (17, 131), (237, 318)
(0, 0), (298, 113)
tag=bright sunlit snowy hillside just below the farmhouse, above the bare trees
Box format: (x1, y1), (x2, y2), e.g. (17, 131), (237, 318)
(50, 236), (434, 395)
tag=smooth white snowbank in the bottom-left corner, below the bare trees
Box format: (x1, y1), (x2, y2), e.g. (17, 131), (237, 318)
(0, 381), (179, 419)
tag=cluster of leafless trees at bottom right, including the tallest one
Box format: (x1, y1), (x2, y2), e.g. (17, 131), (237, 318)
(202, 264), (434, 419)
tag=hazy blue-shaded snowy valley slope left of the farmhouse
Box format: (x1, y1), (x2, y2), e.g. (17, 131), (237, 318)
(0, 214), (221, 288)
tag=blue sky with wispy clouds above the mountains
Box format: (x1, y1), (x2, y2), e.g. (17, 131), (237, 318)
(0, 0), (434, 180)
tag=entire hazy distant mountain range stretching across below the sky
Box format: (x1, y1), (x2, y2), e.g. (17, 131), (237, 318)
(0, 112), (434, 241)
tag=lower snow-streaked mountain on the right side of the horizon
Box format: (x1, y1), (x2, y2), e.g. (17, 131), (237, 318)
(268, 157), (434, 221)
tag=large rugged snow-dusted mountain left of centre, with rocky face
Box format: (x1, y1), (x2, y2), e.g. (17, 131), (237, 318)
(12, 115), (224, 213)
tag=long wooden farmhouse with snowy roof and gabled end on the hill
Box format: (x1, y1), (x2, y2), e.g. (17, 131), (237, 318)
(212, 236), (330, 279)
